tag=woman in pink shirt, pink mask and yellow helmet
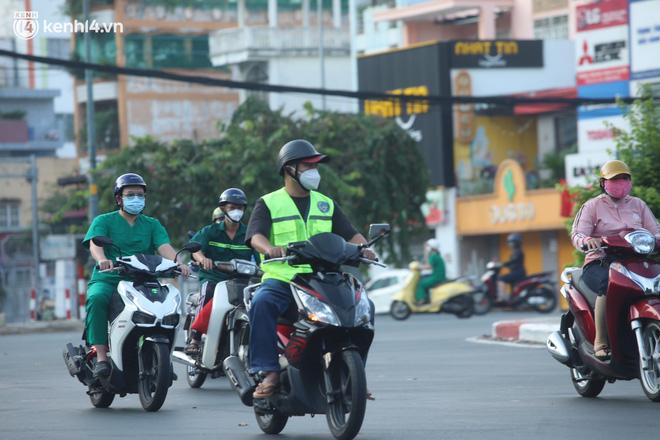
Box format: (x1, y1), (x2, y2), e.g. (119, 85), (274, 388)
(571, 160), (659, 360)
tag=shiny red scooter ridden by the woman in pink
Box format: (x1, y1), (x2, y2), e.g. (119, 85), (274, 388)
(546, 230), (660, 402)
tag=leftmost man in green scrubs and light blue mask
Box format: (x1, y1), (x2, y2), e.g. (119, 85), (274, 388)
(83, 173), (189, 377)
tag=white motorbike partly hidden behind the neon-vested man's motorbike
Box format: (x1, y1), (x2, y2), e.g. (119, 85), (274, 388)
(172, 259), (259, 388)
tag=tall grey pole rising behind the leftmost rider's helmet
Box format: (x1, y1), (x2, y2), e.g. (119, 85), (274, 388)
(83, 0), (98, 223)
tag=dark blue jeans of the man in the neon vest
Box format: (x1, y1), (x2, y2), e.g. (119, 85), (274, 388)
(250, 278), (293, 374)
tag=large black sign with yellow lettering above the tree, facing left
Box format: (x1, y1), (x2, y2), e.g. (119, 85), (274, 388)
(358, 43), (454, 187)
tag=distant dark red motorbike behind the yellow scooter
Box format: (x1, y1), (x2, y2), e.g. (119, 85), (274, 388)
(472, 261), (557, 315)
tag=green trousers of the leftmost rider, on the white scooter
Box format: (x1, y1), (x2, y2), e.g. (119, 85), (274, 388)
(85, 281), (118, 345)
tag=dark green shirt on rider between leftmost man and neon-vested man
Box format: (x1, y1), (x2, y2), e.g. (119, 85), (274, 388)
(191, 222), (259, 283)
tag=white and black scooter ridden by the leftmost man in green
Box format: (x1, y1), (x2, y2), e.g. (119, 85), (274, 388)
(64, 237), (200, 411)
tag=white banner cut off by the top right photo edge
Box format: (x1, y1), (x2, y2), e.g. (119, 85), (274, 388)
(630, 0), (660, 79)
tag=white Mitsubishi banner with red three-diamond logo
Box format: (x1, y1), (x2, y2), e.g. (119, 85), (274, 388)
(575, 26), (630, 86)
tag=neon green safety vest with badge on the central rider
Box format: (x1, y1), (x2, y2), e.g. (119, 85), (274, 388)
(261, 188), (335, 282)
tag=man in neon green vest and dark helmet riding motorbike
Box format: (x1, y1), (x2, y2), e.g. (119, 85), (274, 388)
(246, 139), (376, 399)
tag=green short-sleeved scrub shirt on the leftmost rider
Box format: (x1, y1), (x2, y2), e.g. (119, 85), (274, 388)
(83, 211), (170, 283)
